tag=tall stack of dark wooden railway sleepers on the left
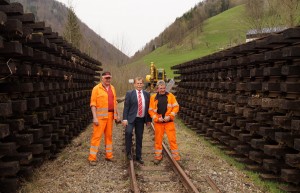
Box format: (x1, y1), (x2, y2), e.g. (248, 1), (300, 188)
(0, 0), (102, 193)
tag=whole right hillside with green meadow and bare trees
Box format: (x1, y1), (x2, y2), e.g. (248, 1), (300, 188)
(129, 0), (300, 74)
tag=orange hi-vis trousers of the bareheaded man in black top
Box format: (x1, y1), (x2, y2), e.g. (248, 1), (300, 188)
(154, 122), (180, 160)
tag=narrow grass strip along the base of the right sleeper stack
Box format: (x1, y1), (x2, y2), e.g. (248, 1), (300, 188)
(176, 119), (285, 193)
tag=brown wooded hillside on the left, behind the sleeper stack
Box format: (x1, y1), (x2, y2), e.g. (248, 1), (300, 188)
(11, 0), (128, 65)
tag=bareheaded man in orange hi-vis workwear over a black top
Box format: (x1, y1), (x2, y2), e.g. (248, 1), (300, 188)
(148, 80), (180, 164)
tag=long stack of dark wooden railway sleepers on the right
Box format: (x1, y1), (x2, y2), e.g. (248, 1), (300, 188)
(172, 27), (300, 190)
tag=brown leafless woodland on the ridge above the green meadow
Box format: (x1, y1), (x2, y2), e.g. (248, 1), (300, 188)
(132, 0), (246, 60)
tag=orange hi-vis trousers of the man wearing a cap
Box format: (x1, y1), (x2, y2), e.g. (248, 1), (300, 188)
(88, 112), (114, 161)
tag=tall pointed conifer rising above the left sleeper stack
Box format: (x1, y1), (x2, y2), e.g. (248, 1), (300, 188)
(63, 6), (82, 49)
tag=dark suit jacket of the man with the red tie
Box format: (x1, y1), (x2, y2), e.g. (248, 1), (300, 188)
(123, 90), (152, 123)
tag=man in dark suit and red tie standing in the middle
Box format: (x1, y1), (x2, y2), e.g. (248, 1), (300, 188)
(122, 77), (151, 164)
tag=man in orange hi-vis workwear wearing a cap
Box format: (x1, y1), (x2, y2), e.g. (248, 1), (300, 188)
(88, 72), (120, 166)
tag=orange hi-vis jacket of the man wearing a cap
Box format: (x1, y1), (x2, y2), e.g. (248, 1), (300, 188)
(90, 83), (118, 119)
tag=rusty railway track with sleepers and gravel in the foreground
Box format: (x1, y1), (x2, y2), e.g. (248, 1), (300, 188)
(128, 124), (221, 193)
